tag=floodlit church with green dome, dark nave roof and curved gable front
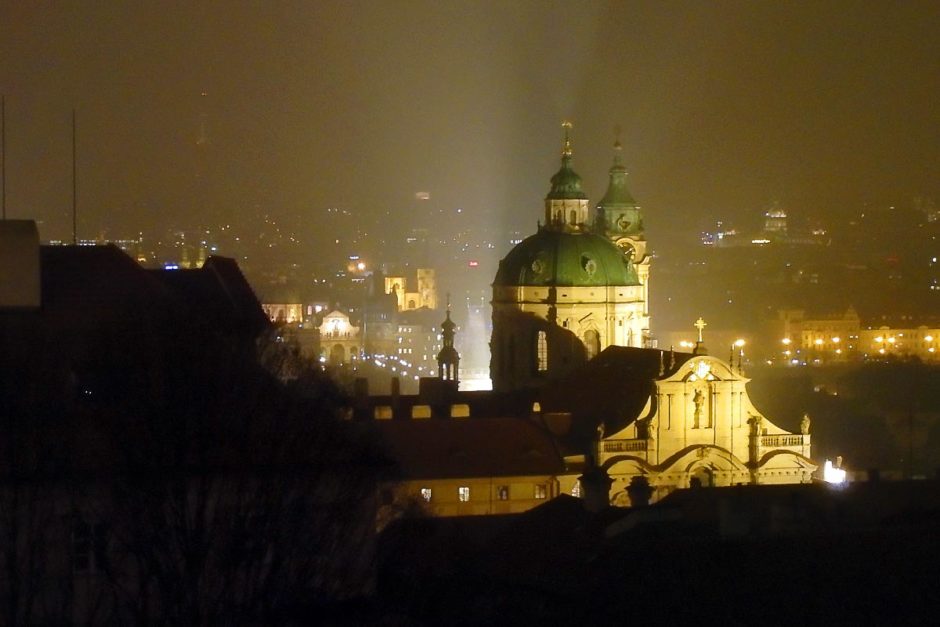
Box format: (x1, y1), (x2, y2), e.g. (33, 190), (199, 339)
(491, 124), (816, 504)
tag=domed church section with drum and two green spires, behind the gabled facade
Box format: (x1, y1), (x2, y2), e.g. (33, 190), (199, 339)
(490, 126), (649, 391)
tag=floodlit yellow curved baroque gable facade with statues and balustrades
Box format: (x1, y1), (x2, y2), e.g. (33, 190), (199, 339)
(596, 353), (816, 503)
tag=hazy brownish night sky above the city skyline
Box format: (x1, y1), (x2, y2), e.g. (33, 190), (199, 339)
(0, 0), (940, 253)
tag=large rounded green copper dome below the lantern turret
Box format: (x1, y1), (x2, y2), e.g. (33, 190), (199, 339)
(493, 228), (640, 287)
